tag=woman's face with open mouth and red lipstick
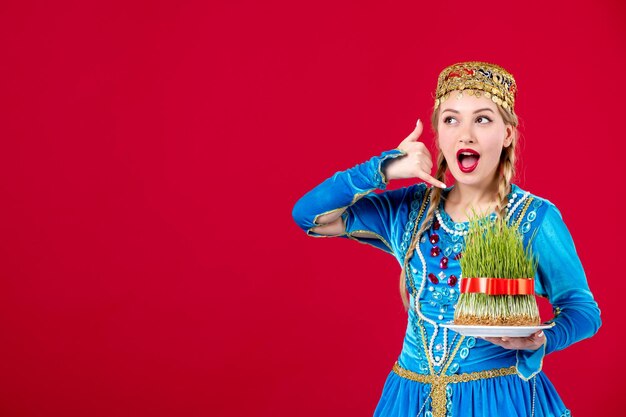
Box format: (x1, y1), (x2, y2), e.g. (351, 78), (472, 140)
(437, 91), (515, 187)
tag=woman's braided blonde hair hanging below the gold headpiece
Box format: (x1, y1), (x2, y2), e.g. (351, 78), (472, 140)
(400, 101), (519, 310)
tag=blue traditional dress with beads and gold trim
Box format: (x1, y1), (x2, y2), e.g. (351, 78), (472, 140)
(293, 149), (601, 417)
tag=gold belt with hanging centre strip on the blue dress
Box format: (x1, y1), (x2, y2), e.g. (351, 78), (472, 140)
(393, 362), (517, 417)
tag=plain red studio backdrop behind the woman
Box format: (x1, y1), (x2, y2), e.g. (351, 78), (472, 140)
(0, 0), (626, 417)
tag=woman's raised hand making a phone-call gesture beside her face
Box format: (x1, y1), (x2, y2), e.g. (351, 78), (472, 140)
(385, 120), (446, 188)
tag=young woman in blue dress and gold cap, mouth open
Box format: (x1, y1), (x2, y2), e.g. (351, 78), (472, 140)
(293, 62), (601, 417)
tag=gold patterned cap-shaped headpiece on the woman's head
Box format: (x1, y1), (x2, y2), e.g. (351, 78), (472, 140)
(435, 61), (517, 113)
